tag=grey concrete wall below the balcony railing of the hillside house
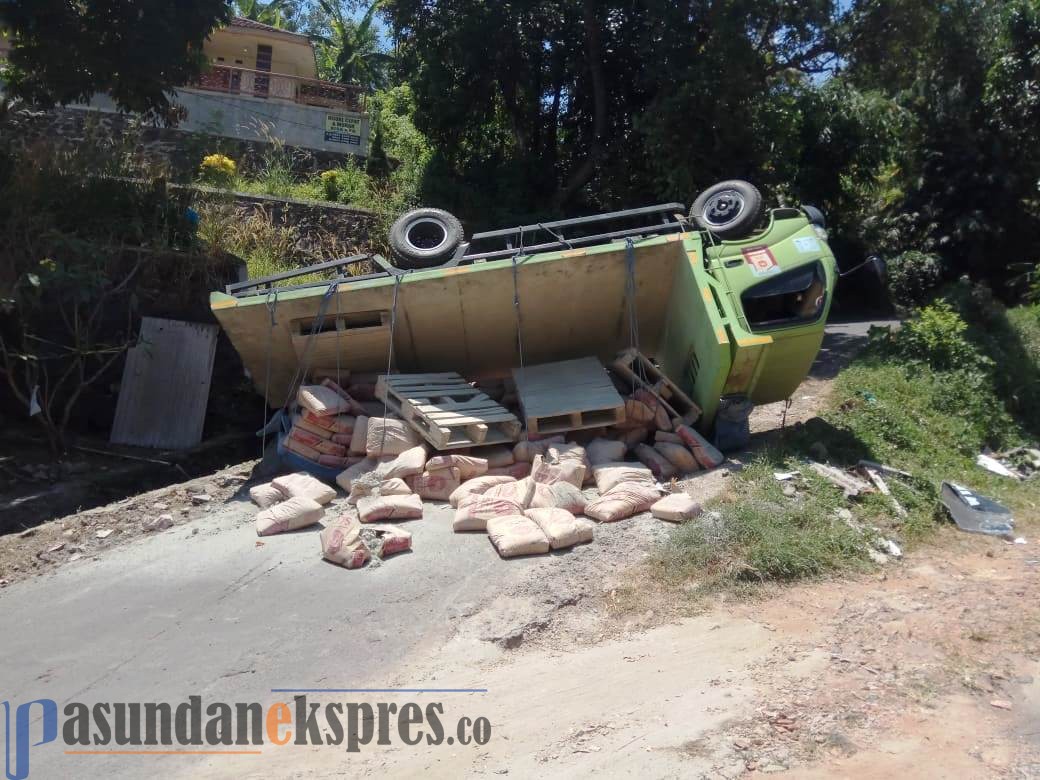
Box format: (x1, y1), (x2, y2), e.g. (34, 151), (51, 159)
(80, 87), (369, 157)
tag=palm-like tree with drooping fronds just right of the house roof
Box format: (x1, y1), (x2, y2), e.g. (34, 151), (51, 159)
(316, 0), (392, 92)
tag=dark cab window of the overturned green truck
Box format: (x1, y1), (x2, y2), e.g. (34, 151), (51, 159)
(740, 260), (827, 331)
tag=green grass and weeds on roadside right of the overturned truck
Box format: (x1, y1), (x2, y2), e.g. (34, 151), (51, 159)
(653, 290), (1040, 588)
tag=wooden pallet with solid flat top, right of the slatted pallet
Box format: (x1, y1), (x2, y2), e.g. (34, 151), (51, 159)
(513, 358), (625, 434)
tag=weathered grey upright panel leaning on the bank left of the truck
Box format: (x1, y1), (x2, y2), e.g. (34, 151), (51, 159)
(109, 317), (218, 449)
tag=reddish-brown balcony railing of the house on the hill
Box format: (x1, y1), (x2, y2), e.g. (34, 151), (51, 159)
(190, 64), (365, 111)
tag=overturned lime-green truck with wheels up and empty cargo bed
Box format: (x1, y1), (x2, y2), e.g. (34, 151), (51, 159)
(210, 181), (837, 431)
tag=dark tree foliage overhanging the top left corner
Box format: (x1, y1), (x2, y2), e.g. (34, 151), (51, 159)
(2, 0), (229, 118)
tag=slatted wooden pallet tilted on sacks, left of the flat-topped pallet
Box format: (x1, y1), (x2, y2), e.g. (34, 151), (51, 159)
(375, 372), (520, 449)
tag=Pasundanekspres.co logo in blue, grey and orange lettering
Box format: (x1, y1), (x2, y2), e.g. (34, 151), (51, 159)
(3, 688), (491, 780)
